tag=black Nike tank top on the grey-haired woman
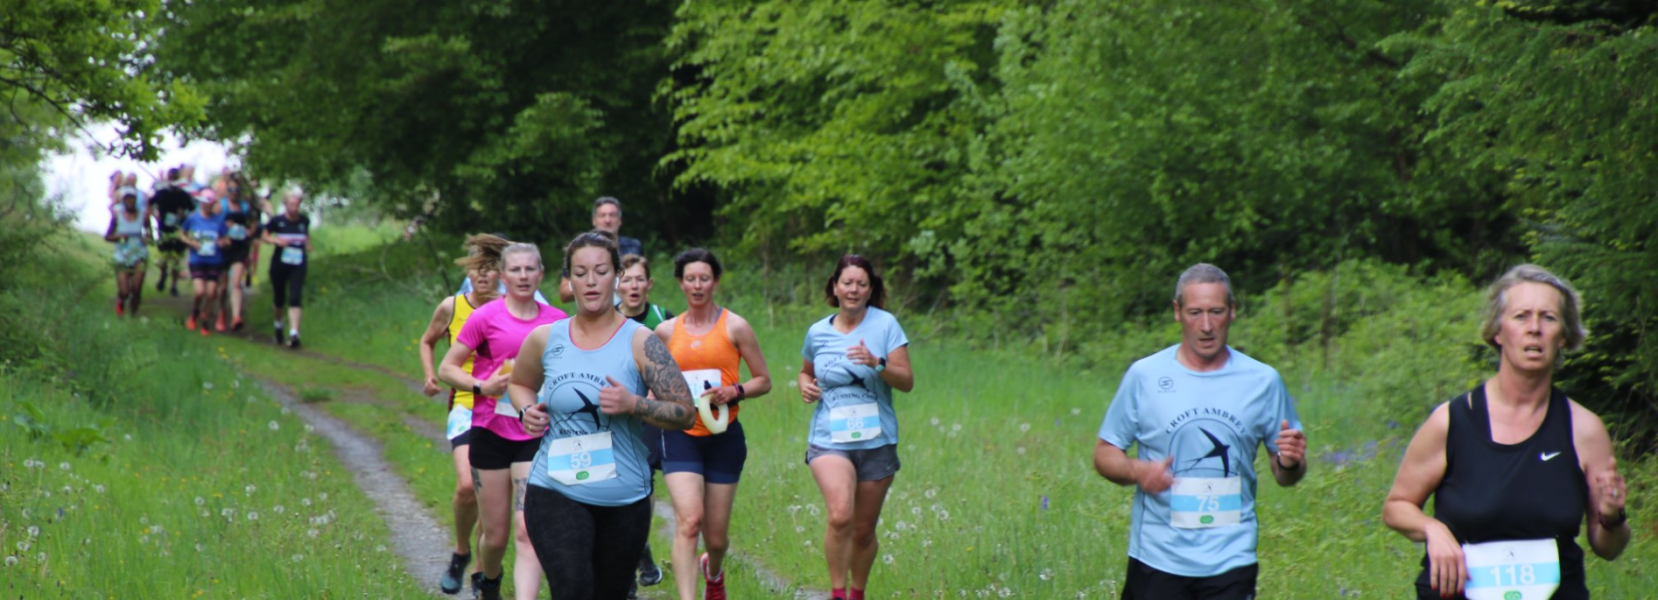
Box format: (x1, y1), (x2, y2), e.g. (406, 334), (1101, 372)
(1416, 385), (1588, 600)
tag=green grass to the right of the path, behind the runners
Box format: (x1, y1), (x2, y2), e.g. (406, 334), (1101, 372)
(230, 227), (1658, 598)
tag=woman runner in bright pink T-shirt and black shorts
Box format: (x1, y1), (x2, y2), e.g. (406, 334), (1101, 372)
(438, 244), (565, 600)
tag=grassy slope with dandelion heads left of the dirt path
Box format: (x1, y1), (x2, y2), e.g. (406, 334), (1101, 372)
(0, 237), (421, 598)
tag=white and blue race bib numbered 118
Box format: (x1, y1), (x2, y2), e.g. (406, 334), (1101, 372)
(1462, 539), (1560, 600)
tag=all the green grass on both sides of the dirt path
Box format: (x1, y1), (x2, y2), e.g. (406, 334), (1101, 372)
(16, 229), (1658, 598)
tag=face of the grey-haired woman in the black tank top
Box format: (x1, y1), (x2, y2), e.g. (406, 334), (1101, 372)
(1496, 282), (1565, 371)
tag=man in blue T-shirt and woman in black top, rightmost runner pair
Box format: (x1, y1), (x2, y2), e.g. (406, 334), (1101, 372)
(1094, 264), (1630, 600)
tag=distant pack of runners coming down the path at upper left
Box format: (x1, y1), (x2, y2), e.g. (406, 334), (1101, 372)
(104, 164), (312, 348)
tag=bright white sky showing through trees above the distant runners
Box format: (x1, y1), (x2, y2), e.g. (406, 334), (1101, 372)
(41, 124), (234, 232)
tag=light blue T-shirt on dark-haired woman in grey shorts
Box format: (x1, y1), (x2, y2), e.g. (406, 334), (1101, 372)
(801, 307), (910, 449)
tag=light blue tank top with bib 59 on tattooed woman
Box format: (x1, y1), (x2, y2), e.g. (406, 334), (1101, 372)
(529, 318), (650, 506)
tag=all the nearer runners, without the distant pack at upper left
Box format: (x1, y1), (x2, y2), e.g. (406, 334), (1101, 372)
(421, 197), (1630, 600)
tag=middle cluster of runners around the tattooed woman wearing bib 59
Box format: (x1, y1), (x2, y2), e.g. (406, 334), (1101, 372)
(419, 197), (914, 600)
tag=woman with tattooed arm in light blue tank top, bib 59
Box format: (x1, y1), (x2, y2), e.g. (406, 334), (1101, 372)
(509, 232), (695, 600)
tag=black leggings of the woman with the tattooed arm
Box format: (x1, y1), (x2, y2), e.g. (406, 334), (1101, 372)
(524, 486), (650, 600)
